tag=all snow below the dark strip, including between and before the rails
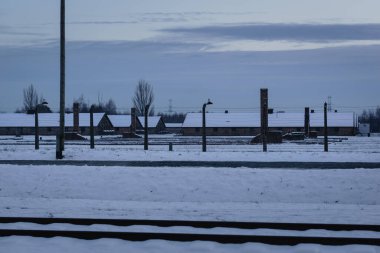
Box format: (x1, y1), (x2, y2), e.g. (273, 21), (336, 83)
(0, 165), (380, 253)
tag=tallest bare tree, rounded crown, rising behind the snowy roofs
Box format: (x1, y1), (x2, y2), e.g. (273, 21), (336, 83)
(133, 80), (154, 116)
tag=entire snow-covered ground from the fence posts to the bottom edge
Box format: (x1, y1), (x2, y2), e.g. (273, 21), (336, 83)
(0, 134), (380, 253)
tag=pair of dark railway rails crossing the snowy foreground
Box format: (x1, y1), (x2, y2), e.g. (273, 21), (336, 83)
(0, 217), (380, 246)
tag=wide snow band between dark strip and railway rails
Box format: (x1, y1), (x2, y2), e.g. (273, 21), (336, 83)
(0, 165), (380, 224)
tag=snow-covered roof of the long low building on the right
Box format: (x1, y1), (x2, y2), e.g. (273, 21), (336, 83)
(182, 113), (354, 127)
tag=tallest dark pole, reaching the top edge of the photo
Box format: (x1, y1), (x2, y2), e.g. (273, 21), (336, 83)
(56, 0), (65, 159)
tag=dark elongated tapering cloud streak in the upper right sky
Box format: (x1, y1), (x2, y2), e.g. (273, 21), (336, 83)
(164, 24), (380, 42)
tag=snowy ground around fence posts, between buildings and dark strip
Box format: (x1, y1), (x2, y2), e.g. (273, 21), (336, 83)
(0, 136), (380, 162)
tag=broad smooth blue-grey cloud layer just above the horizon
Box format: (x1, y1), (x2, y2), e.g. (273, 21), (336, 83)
(0, 41), (380, 110)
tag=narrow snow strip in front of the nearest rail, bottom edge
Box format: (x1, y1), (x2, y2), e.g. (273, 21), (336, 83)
(0, 236), (380, 253)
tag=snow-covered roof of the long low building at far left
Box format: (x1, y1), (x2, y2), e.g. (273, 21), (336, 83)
(0, 113), (104, 127)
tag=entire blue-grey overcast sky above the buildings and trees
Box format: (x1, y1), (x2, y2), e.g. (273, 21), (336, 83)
(0, 0), (380, 112)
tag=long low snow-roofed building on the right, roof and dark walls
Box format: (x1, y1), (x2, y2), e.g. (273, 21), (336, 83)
(182, 112), (357, 136)
